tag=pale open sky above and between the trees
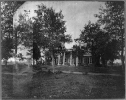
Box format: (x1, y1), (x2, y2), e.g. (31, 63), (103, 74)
(14, 1), (104, 57)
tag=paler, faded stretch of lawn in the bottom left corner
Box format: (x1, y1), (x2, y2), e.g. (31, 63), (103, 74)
(2, 74), (32, 99)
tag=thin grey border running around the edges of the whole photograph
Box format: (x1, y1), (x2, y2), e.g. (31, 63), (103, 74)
(0, 0), (126, 100)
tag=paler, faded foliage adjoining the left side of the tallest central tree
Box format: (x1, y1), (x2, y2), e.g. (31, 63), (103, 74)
(14, 11), (33, 48)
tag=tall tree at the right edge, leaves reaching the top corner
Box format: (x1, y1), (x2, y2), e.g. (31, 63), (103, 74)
(95, 1), (125, 69)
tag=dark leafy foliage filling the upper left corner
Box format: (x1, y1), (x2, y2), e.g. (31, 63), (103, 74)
(1, 1), (24, 50)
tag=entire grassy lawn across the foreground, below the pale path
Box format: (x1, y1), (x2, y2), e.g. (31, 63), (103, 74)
(2, 63), (125, 99)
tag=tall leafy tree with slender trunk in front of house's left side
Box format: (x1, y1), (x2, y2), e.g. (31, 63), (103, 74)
(34, 4), (71, 71)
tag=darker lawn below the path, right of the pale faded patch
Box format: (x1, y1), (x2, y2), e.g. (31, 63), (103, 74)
(31, 73), (125, 99)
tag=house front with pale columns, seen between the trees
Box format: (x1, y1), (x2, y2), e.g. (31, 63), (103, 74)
(55, 49), (92, 66)
